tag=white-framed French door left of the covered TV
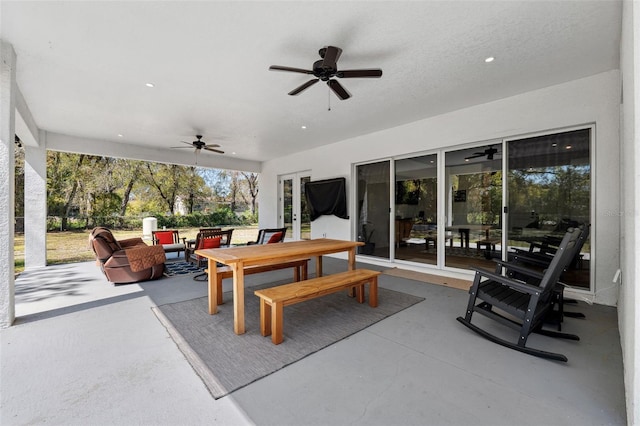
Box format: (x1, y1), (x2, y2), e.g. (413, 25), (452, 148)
(278, 171), (311, 241)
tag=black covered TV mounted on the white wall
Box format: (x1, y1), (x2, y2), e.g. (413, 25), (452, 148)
(304, 178), (349, 220)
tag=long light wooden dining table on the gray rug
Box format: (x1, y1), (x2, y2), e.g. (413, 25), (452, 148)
(196, 238), (364, 334)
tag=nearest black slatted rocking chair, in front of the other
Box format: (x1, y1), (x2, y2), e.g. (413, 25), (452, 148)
(457, 228), (581, 361)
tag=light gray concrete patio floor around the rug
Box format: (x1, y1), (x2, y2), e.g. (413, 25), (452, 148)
(0, 258), (626, 425)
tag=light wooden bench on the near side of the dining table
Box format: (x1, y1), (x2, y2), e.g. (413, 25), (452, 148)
(254, 269), (381, 345)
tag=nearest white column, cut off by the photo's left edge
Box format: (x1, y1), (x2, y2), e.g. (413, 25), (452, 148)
(0, 40), (16, 328)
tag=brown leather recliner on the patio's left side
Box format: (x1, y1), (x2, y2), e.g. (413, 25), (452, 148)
(89, 227), (166, 284)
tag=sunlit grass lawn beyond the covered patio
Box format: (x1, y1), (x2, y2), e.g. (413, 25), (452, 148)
(13, 225), (258, 273)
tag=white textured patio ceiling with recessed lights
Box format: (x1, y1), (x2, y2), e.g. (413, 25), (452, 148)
(0, 0), (621, 165)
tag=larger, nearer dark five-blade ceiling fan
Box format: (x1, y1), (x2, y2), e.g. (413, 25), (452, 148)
(269, 46), (382, 100)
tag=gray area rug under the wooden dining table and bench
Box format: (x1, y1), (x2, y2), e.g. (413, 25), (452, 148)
(153, 283), (424, 399)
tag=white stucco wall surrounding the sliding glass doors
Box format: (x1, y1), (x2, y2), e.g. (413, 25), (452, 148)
(260, 71), (620, 305)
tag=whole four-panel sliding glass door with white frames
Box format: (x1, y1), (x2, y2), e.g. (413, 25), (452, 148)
(355, 127), (593, 289)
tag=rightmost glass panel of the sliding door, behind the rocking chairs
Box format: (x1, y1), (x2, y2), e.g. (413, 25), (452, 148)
(507, 128), (592, 289)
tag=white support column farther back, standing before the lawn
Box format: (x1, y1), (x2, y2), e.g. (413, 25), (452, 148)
(24, 131), (47, 269)
